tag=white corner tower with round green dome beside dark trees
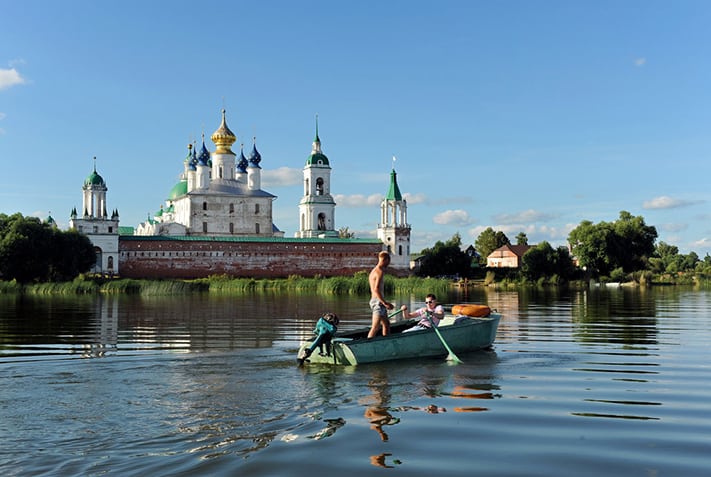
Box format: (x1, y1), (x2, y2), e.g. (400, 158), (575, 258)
(69, 158), (119, 275)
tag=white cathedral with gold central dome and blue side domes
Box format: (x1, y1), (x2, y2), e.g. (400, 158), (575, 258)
(136, 110), (284, 237)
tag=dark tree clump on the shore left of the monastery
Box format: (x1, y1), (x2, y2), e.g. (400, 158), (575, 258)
(0, 213), (96, 283)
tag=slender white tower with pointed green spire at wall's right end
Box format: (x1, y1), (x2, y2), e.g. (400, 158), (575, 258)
(378, 168), (410, 271)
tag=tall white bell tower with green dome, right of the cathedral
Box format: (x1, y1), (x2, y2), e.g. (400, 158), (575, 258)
(294, 118), (338, 238)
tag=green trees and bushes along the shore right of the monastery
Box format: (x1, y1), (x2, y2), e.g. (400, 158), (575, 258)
(418, 210), (711, 281)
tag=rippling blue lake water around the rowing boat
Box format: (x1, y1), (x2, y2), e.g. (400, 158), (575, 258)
(0, 287), (711, 477)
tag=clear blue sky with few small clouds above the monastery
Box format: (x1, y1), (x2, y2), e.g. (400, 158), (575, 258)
(0, 0), (711, 257)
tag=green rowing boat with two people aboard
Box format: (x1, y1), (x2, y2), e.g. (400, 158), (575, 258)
(297, 305), (501, 365)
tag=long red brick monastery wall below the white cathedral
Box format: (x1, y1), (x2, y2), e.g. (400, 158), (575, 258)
(119, 236), (408, 278)
